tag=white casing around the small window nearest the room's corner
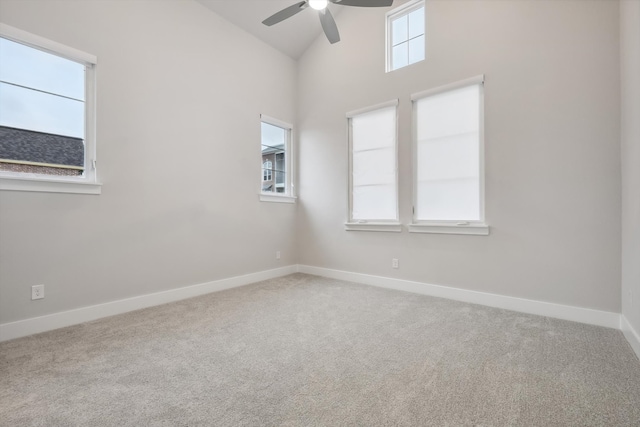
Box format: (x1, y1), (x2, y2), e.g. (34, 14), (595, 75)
(259, 114), (296, 203)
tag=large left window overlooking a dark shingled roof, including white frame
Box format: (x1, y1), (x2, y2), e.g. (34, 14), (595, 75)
(0, 24), (100, 194)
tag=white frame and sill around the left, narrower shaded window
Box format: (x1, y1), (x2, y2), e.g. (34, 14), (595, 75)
(344, 99), (402, 232)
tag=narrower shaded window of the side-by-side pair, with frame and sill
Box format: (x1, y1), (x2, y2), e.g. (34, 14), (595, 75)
(346, 100), (401, 231)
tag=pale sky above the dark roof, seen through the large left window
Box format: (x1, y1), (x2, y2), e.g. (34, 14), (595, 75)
(0, 37), (85, 139)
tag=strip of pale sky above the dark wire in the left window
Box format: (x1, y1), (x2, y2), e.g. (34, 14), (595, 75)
(0, 38), (85, 100)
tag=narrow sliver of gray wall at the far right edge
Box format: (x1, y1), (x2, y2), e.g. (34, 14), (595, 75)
(620, 0), (640, 331)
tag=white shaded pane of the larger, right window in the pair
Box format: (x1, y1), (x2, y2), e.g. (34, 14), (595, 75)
(416, 85), (480, 221)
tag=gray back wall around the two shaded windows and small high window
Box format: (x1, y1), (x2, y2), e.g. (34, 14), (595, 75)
(298, 0), (624, 312)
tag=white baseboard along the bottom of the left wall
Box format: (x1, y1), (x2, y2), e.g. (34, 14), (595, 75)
(0, 265), (297, 342)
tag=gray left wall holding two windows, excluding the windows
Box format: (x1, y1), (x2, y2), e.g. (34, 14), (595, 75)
(0, 0), (297, 323)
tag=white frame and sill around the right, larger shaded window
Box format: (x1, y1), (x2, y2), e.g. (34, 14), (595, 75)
(409, 75), (489, 236)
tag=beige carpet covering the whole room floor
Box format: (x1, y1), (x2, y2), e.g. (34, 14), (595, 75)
(0, 274), (640, 427)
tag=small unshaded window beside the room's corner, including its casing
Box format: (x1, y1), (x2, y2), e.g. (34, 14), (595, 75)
(260, 115), (295, 203)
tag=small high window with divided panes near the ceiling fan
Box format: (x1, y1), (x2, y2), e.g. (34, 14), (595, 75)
(387, 0), (425, 71)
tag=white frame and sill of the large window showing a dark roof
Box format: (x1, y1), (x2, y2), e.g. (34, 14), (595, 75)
(0, 23), (102, 194)
